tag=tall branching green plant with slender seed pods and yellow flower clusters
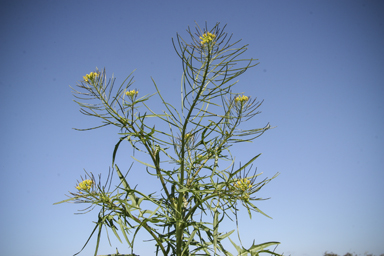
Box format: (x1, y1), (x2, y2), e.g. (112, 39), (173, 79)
(54, 24), (279, 256)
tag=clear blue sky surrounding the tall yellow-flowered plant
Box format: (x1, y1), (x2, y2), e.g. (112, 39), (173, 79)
(0, 0), (384, 256)
